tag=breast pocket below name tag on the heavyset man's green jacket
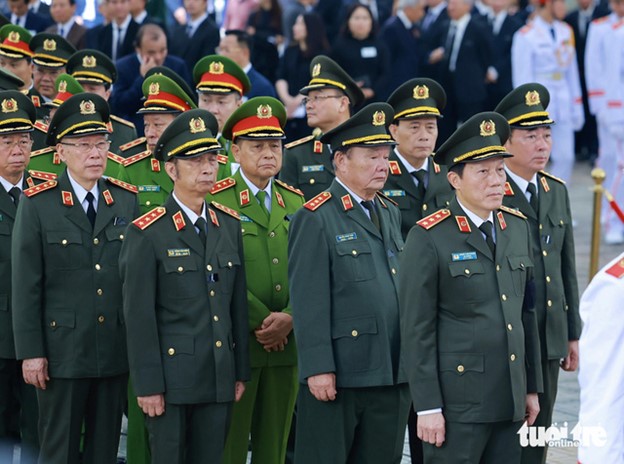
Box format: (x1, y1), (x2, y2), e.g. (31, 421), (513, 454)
(334, 240), (377, 282)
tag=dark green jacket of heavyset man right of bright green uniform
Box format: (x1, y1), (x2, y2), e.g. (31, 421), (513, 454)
(288, 181), (406, 388)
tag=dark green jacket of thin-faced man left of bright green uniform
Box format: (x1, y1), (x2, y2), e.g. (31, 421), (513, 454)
(119, 196), (250, 404)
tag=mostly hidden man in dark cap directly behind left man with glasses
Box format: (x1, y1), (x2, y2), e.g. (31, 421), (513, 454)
(67, 49), (137, 154)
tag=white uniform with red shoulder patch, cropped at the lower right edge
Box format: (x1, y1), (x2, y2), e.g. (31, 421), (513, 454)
(578, 253), (624, 464)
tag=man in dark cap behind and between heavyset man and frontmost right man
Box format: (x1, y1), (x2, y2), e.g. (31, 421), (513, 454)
(383, 78), (452, 239)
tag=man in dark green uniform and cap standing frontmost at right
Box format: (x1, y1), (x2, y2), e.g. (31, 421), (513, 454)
(400, 112), (542, 464)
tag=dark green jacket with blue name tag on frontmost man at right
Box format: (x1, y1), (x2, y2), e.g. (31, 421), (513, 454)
(400, 199), (542, 423)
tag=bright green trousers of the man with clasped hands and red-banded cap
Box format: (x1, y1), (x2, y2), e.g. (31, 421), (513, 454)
(223, 366), (299, 464)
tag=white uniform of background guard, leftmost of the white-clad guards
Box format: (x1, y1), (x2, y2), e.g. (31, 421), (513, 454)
(511, 16), (585, 182)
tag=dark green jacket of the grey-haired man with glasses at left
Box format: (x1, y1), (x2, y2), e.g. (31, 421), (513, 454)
(11, 173), (138, 379)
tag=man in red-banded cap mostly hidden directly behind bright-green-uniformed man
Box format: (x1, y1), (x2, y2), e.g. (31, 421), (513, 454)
(193, 55), (251, 180)
